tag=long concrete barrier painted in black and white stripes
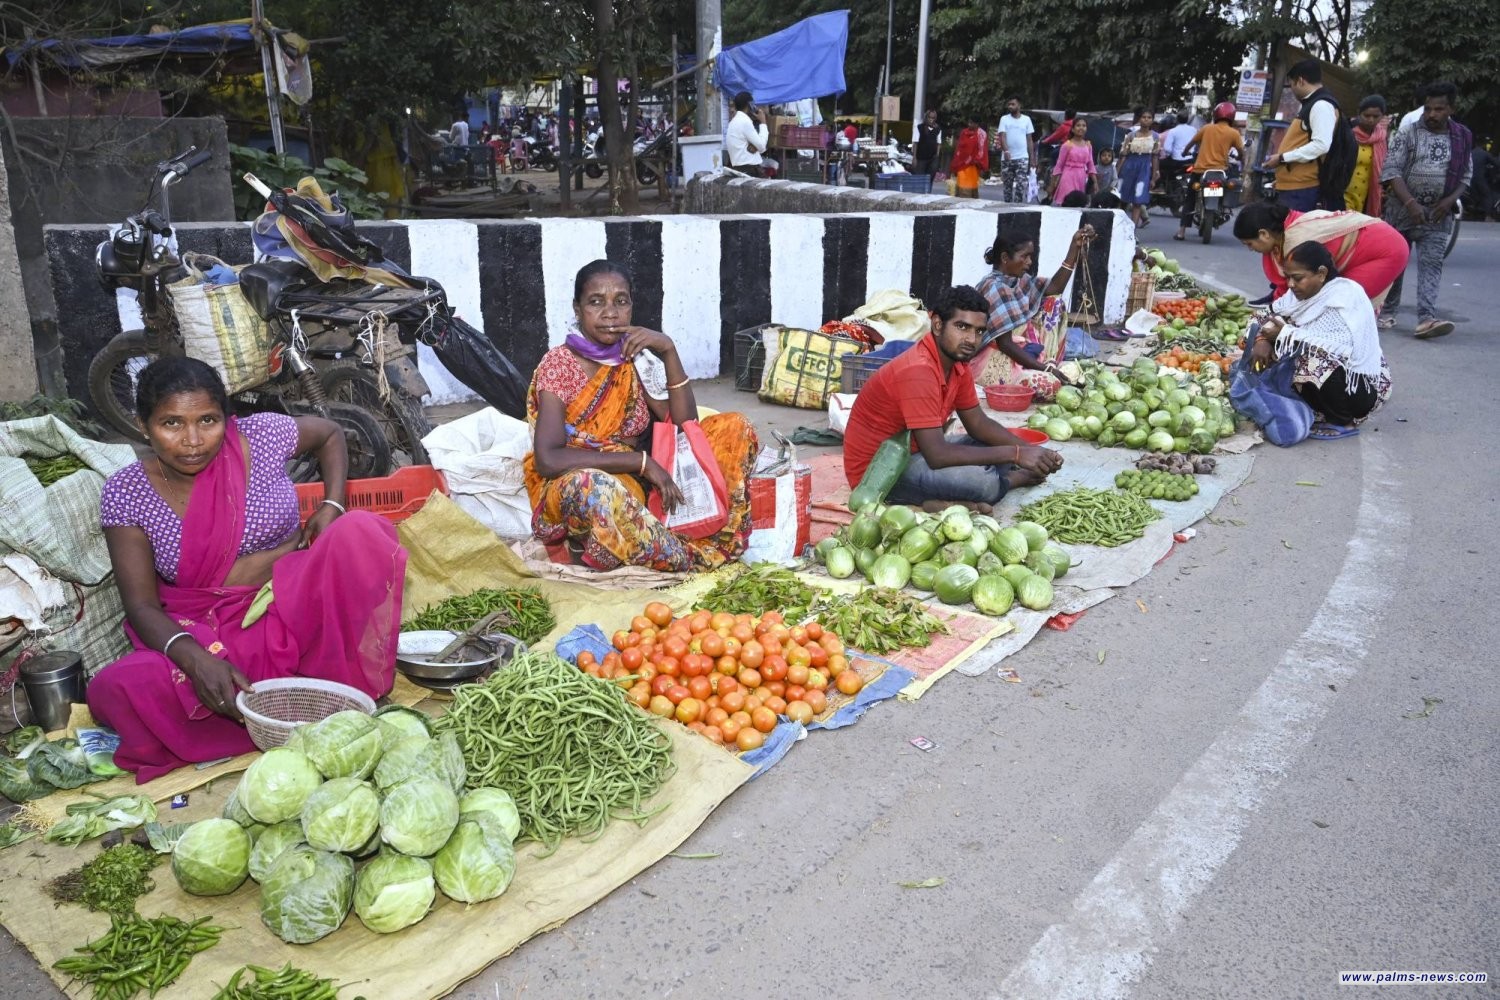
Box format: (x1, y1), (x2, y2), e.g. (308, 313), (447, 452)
(45, 205), (1136, 403)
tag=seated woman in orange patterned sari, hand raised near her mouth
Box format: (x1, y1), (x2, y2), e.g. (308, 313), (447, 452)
(525, 261), (759, 571)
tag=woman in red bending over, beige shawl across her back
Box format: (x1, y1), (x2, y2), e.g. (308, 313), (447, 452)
(1235, 201), (1412, 322)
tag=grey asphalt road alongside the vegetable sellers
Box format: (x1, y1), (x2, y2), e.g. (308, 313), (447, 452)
(0, 219), (1500, 1000)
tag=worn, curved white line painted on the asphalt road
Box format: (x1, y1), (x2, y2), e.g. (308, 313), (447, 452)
(996, 436), (1410, 1000)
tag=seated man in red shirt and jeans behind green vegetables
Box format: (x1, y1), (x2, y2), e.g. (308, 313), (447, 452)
(845, 285), (1062, 505)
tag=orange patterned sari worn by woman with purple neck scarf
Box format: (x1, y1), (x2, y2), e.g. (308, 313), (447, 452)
(525, 346), (759, 573)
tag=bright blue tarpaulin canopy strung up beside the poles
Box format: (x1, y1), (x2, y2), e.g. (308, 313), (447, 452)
(717, 10), (849, 105)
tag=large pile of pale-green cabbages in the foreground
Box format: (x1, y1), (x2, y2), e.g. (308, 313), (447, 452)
(173, 706), (521, 945)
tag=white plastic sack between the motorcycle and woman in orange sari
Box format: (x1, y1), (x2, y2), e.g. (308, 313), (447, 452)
(422, 406), (531, 538)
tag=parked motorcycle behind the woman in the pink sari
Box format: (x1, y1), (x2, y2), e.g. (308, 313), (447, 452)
(89, 147), (446, 481)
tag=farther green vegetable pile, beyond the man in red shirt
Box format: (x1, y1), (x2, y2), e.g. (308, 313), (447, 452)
(1026, 357), (1235, 454)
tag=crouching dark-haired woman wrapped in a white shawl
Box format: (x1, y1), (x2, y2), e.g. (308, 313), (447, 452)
(1251, 243), (1391, 441)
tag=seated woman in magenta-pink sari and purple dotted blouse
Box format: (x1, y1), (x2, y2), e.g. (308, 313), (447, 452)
(89, 358), (407, 783)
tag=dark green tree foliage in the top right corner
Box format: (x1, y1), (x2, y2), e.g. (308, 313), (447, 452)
(1361, 0), (1500, 135)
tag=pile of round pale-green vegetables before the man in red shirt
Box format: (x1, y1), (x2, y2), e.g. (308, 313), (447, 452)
(813, 504), (1073, 615)
